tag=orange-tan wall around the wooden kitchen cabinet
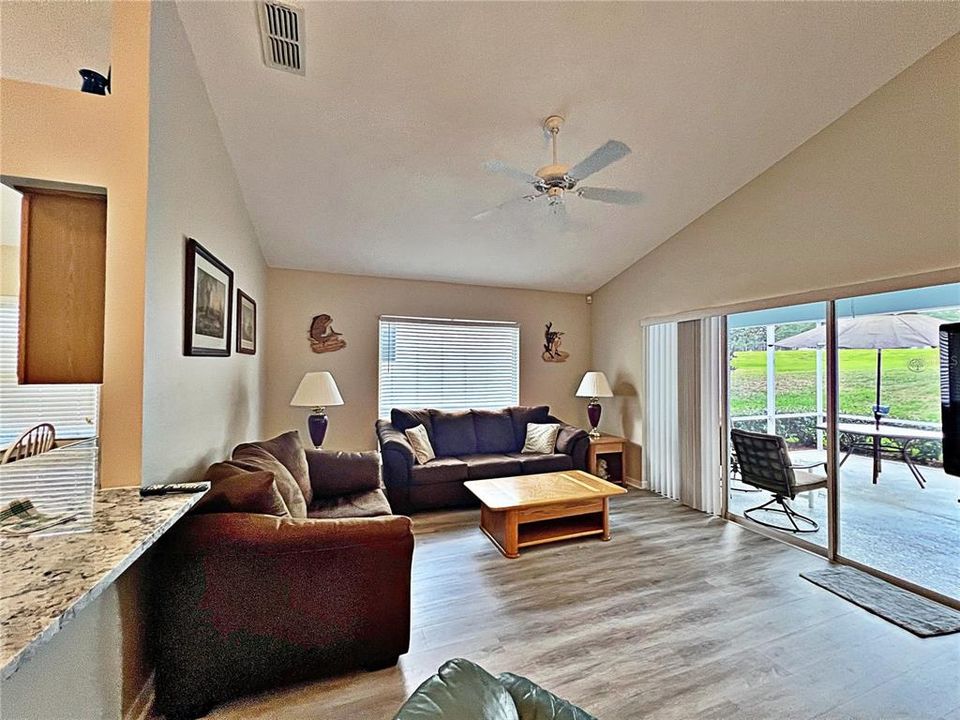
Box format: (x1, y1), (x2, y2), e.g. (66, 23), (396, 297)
(0, 2), (150, 486)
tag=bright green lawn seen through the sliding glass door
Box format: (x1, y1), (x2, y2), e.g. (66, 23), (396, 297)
(730, 348), (940, 422)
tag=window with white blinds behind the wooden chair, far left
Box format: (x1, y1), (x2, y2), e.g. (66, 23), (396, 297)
(0, 296), (100, 447)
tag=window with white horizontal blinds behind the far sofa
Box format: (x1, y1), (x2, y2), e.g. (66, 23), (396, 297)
(379, 315), (520, 417)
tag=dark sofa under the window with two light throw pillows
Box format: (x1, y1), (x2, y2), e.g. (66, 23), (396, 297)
(377, 405), (590, 513)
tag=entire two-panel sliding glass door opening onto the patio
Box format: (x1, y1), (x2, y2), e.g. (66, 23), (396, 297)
(725, 284), (960, 598)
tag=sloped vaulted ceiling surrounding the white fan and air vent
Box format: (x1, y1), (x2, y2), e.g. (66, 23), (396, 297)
(179, 1), (960, 292)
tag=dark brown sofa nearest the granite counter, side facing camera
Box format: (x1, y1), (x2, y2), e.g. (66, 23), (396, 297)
(154, 433), (413, 720)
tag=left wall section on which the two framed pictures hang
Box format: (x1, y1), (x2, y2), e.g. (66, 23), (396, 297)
(143, 3), (266, 483)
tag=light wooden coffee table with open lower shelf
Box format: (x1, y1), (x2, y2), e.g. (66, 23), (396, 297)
(464, 470), (627, 558)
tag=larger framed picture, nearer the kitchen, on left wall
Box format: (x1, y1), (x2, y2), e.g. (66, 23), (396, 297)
(183, 238), (233, 357)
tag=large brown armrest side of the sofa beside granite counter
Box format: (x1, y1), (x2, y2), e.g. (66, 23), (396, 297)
(152, 513), (414, 718)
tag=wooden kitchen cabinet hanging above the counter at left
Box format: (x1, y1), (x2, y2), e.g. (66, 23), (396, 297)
(17, 188), (107, 383)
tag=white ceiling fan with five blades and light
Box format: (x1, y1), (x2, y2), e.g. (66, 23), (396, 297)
(473, 115), (642, 220)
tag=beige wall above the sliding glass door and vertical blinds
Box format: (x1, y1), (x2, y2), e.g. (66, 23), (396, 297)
(593, 36), (960, 476)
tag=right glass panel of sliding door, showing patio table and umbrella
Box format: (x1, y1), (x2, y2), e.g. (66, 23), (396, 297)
(836, 285), (960, 598)
